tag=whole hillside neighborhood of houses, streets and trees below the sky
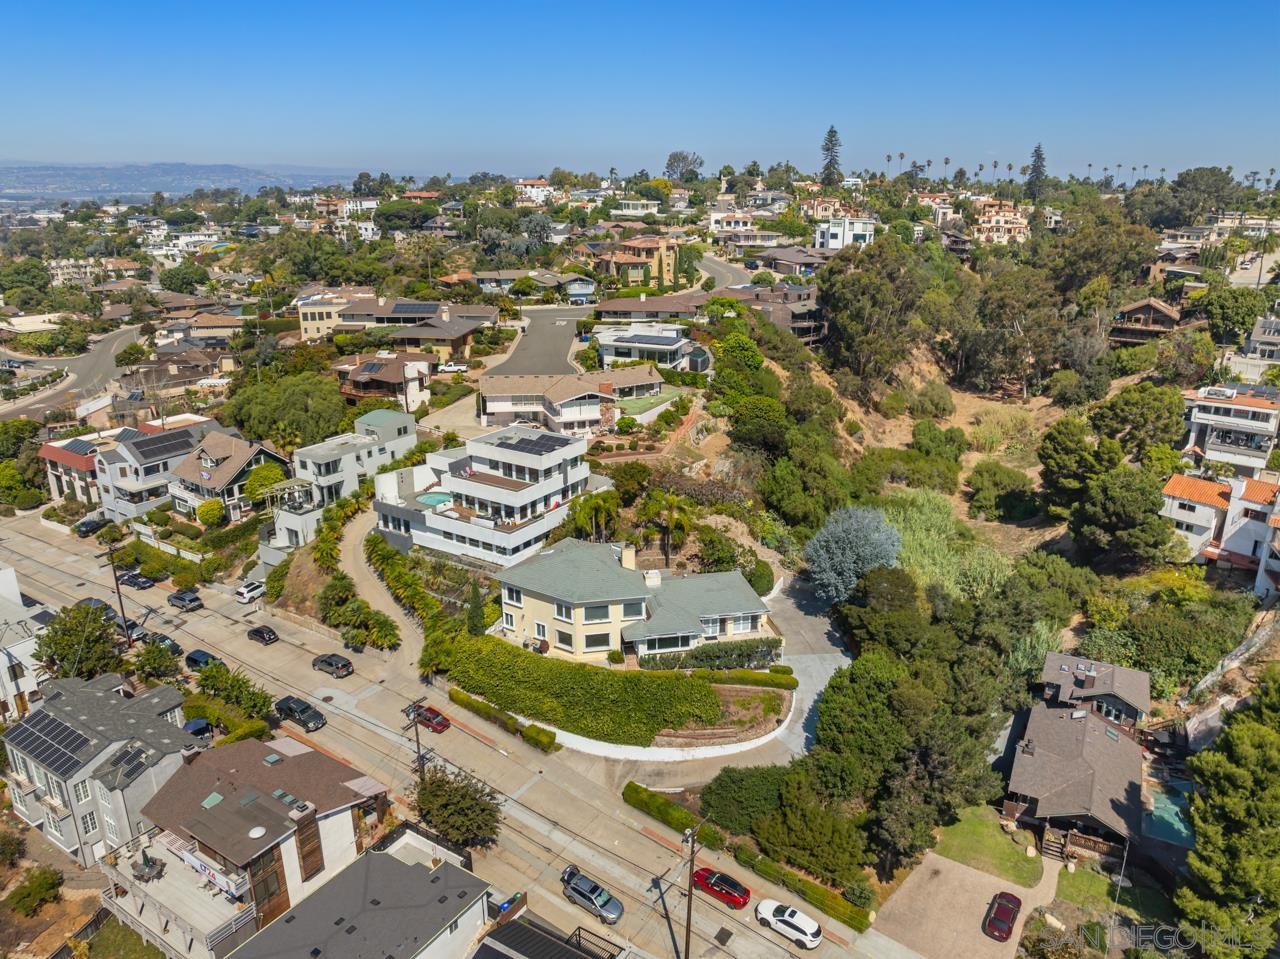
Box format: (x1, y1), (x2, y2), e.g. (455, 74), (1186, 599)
(0, 29), (1280, 959)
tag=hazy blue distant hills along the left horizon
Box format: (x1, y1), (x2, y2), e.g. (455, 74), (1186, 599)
(0, 163), (353, 200)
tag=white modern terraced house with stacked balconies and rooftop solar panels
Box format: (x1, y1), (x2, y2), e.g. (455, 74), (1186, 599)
(374, 426), (596, 566)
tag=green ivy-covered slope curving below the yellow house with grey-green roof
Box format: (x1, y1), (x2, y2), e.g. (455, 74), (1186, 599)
(365, 534), (721, 745)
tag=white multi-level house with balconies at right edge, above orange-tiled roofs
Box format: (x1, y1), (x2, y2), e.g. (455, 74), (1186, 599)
(1183, 383), (1280, 476)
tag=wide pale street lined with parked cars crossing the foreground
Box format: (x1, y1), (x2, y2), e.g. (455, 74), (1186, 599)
(0, 516), (867, 959)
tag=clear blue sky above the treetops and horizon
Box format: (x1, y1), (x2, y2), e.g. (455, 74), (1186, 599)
(10, 0), (1280, 177)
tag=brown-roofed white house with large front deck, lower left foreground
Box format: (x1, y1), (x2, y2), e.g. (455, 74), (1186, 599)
(102, 737), (388, 959)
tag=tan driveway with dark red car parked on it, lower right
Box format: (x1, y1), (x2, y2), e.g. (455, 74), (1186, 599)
(876, 853), (1062, 959)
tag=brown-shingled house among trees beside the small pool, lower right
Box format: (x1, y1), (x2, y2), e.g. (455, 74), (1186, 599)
(1004, 653), (1151, 859)
